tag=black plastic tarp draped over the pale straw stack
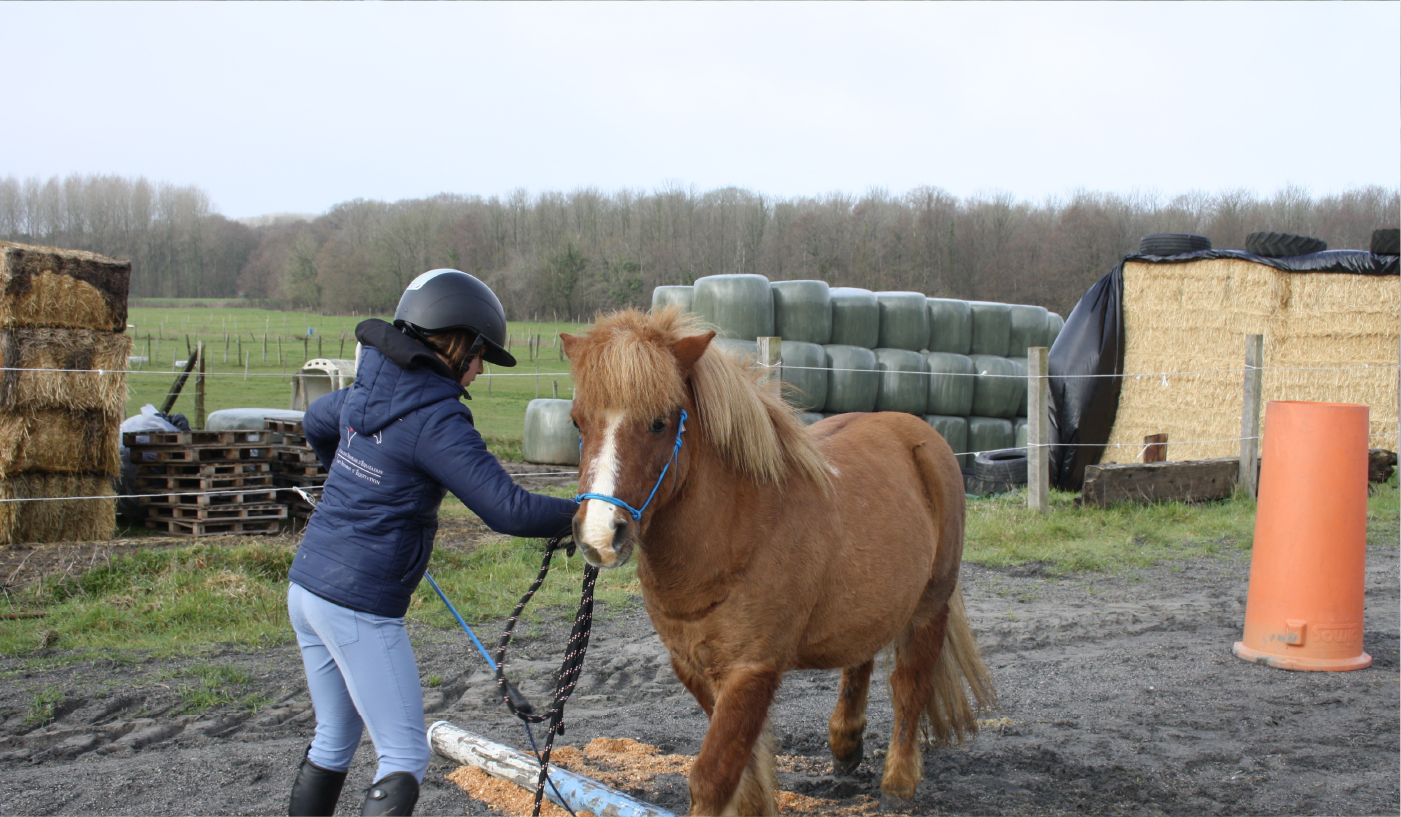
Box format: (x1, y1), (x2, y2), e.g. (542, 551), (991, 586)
(1047, 249), (1401, 490)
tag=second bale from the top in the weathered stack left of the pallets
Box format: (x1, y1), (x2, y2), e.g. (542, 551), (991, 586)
(0, 328), (132, 413)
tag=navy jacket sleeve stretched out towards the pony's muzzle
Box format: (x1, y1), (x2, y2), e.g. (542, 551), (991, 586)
(411, 401), (579, 540)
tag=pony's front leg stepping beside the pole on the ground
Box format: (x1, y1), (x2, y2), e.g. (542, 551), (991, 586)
(691, 667), (782, 817)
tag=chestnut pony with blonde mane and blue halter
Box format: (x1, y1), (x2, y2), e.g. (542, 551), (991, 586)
(563, 308), (993, 814)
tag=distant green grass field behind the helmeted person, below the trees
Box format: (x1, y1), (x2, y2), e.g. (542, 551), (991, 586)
(126, 305), (581, 455)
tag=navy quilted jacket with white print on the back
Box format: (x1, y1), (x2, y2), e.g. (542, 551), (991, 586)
(289, 321), (577, 618)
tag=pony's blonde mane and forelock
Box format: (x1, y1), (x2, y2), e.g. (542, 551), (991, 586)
(570, 307), (831, 492)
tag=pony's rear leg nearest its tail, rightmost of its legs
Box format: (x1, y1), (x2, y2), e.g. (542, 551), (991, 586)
(880, 605), (948, 811)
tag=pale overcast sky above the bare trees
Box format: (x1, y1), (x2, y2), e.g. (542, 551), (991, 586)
(0, 3), (1401, 217)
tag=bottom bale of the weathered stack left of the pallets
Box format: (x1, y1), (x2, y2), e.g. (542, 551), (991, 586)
(0, 474), (116, 545)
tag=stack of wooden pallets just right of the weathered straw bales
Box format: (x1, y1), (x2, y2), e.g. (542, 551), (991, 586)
(123, 432), (287, 537)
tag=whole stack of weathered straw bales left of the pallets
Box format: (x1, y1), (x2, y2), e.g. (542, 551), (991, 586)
(0, 241), (132, 544)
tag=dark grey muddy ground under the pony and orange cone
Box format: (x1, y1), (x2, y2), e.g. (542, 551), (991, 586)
(0, 493), (1401, 816)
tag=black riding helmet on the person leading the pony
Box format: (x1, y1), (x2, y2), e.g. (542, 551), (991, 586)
(394, 269), (516, 366)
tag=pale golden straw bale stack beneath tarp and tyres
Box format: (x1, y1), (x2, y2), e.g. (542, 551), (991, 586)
(1101, 258), (1401, 462)
